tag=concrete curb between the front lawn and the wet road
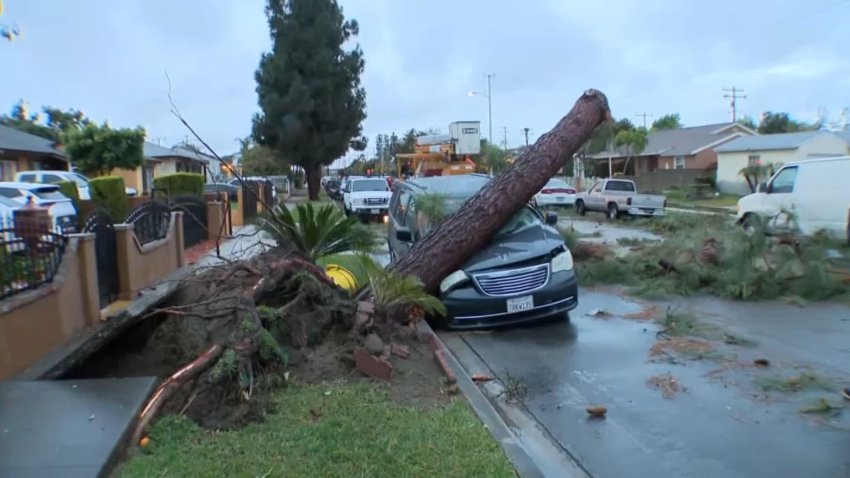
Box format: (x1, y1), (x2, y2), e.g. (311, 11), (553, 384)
(417, 320), (546, 478)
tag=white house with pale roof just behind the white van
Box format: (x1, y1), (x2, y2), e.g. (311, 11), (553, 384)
(715, 131), (848, 194)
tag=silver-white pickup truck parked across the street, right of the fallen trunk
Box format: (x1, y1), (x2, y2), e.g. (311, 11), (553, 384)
(576, 179), (667, 219)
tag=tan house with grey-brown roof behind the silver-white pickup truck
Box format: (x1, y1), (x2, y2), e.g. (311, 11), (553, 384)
(590, 123), (757, 177)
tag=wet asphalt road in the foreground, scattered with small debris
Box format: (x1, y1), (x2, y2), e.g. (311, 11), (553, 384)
(441, 290), (850, 478)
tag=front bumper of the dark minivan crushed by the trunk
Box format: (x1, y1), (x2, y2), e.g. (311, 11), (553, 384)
(441, 271), (578, 329)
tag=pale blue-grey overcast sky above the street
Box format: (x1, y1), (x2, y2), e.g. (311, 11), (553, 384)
(0, 0), (850, 164)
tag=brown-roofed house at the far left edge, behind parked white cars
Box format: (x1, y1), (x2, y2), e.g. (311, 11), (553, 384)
(0, 125), (70, 181)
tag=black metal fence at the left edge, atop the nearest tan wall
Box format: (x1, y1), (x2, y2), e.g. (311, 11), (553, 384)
(0, 218), (68, 299)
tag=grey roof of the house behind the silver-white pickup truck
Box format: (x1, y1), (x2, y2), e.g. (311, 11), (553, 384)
(592, 123), (756, 158)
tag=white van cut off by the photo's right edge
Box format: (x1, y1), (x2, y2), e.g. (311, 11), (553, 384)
(738, 156), (850, 239)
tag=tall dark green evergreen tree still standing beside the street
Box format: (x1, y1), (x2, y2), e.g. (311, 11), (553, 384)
(253, 0), (366, 199)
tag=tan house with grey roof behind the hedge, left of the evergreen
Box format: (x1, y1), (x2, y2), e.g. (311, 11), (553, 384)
(111, 141), (209, 193)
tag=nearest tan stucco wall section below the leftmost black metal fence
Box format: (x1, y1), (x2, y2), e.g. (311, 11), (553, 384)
(0, 234), (100, 380)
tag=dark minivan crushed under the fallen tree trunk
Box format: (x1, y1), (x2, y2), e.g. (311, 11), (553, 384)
(387, 174), (578, 329)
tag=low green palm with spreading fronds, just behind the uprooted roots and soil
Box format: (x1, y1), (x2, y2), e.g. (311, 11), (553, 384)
(260, 203), (376, 262)
